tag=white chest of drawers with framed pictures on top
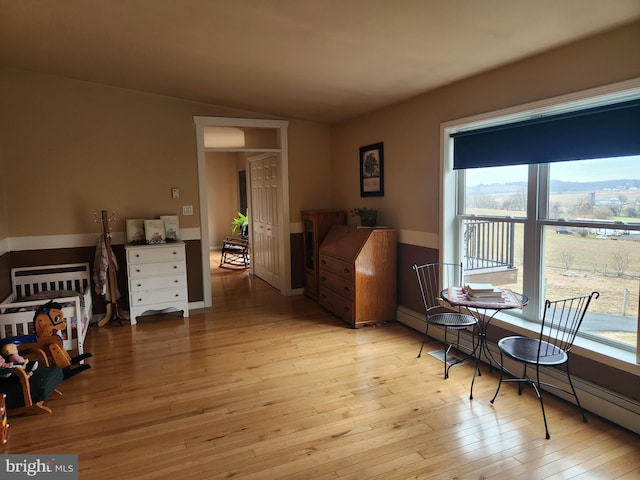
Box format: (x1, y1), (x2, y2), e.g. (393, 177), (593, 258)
(125, 242), (189, 325)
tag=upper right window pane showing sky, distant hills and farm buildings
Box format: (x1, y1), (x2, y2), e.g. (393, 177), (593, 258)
(549, 156), (640, 223)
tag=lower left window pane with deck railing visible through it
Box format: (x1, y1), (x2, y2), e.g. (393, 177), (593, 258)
(463, 219), (524, 292)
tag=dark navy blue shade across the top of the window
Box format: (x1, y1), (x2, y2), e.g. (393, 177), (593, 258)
(451, 99), (640, 169)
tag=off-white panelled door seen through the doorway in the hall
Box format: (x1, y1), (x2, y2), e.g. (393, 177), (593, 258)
(249, 155), (282, 290)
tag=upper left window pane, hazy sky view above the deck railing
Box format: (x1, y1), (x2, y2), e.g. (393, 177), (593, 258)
(463, 165), (528, 217)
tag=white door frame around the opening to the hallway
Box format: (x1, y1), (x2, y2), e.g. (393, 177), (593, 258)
(193, 116), (292, 307)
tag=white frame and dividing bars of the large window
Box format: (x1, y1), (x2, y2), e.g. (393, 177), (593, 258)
(440, 79), (640, 363)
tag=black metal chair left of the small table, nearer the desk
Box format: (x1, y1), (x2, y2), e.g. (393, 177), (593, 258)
(411, 263), (478, 379)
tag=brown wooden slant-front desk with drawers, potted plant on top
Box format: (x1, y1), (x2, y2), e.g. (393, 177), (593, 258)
(318, 225), (397, 328)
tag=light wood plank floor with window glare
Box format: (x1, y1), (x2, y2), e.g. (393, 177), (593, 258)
(0, 253), (640, 480)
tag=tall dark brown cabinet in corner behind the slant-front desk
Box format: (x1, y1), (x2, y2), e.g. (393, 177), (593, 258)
(301, 210), (347, 300)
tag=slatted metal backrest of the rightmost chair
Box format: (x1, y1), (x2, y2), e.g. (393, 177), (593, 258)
(539, 292), (600, 357)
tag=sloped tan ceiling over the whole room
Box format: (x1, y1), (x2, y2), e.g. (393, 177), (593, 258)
(0, 0), (640, 123)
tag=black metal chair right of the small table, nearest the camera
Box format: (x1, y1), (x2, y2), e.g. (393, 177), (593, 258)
(491, 292), (600, 440)
